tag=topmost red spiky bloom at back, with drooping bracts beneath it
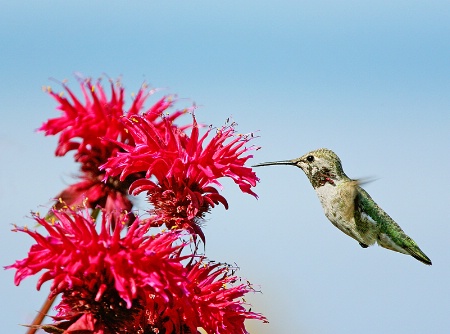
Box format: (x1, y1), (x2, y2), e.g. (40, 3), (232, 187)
(39, 79), (183, 212)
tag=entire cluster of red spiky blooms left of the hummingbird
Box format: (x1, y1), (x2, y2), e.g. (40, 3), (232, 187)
(6, 80), (267, 334)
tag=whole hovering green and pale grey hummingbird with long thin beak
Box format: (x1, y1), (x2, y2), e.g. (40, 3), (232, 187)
(252, 148), (431, 265)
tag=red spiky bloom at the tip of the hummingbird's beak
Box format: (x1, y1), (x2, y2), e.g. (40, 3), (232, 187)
(101, 115), (258, 241)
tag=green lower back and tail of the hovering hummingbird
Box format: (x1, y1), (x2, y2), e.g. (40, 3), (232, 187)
(355, 186), (431, 265)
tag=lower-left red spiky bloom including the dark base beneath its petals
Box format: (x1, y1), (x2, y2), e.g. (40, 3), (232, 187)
(7, 210), (186, 333)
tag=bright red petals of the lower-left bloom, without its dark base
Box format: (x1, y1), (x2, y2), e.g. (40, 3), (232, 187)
(9, 210), (188, 302)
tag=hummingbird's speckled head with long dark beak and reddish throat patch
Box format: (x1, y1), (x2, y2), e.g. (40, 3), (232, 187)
(252, 148), (347, 189)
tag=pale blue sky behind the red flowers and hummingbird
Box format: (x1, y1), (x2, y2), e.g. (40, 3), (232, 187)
(0, 0), (450, 334)
